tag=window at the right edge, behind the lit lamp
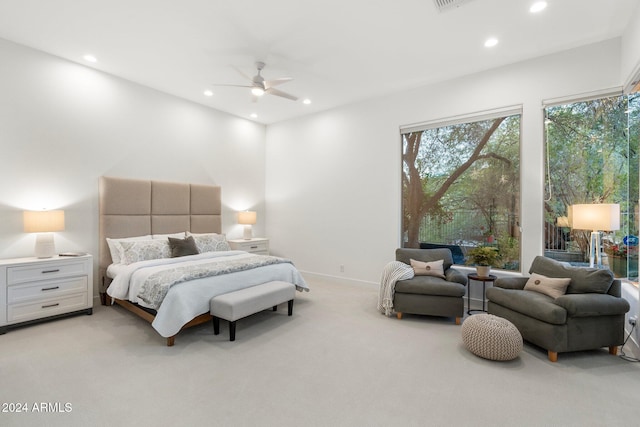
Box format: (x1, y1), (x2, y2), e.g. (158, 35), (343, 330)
(544, 94), (640, 281)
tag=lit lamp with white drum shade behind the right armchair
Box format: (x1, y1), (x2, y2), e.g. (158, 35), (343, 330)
(571, 203), (620, 267)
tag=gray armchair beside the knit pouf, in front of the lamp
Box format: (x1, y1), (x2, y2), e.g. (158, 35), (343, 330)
(487, 256), (629, 362)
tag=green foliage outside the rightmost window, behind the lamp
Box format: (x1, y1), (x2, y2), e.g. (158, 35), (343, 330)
(545, 94), (640, 264)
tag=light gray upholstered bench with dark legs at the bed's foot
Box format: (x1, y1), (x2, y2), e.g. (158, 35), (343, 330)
(209, 281), (296, 341)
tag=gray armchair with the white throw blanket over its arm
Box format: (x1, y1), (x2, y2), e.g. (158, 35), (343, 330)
(393, 248), (467, 325)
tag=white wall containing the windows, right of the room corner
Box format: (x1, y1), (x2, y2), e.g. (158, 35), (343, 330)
(266, 39), (621, 283)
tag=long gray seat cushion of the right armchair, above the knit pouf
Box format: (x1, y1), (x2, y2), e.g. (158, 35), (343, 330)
(487, 287), (567, 325)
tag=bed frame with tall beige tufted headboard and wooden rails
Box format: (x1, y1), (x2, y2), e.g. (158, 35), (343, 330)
(98, 177), (222, 346)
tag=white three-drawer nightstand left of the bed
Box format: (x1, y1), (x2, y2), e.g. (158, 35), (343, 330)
(0, 255), (93, 334)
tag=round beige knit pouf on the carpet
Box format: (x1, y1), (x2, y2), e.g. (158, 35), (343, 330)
(462, 314), (522, 360)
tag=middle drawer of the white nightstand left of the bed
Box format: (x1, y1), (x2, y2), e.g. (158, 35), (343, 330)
(7, 276), (87, 304)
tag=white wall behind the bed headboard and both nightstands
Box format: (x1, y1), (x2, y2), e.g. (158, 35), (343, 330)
(0, 40), (265, 294)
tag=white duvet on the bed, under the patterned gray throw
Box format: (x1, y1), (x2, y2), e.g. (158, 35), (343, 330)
(107, 251), (309, 337)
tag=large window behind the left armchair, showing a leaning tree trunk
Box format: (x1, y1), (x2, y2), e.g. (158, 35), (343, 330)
(402, 109), (520, 270)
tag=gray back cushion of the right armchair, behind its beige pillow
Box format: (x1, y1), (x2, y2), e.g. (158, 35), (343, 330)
(529, 256), (613, 294)
